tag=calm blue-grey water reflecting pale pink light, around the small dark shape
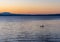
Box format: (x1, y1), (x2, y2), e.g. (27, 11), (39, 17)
(0, 16), (60, 42)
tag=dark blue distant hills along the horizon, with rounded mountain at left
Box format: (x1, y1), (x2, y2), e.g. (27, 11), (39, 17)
(0, 12), (60, 16)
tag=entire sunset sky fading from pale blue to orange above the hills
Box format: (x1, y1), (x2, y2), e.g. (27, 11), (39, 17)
(0, 0), (60, 14)
